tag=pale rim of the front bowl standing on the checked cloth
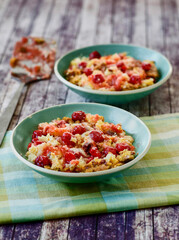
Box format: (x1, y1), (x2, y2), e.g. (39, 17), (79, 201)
(10, 103), (151, 178)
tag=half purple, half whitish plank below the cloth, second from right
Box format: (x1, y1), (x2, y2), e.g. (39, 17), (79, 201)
(125, 209), (153, 240)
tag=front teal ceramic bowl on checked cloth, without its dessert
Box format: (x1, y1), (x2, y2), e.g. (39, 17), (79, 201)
(11, 103), (151, 183)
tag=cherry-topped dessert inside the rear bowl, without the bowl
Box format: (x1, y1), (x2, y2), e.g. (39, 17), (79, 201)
(65, 51), (159, 91)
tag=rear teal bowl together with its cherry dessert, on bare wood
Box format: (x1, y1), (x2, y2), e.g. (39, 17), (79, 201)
(54, 44), (172, 105)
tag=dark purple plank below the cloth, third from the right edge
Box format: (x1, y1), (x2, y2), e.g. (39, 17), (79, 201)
(96, 212), (125, 240)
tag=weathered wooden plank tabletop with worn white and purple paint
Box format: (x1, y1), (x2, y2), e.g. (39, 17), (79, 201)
(0, 0), (179, 240)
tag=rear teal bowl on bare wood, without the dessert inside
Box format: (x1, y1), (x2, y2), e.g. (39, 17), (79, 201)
(54, 44), (172, 105)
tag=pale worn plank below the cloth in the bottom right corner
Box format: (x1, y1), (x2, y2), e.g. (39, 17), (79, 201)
(154, 206), (179, 240)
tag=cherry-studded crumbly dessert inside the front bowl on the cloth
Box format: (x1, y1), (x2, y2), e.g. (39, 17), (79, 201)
(26, 111), (135, 172)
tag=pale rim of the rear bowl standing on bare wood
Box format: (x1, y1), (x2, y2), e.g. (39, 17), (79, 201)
(54, 43), (173, 95)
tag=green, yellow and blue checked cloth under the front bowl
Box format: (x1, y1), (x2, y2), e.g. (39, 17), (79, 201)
(0, 114), (179, 223)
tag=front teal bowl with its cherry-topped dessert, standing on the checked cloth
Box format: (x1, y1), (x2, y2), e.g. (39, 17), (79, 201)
(11, 103), (151, 183)
